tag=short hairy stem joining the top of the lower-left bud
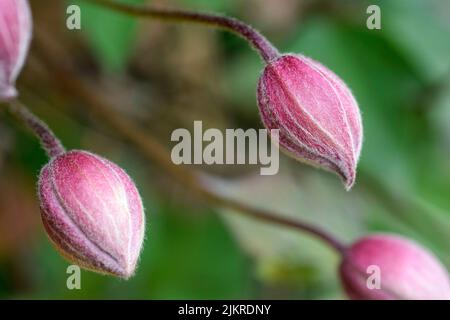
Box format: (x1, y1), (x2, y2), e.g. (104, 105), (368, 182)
(9, 100), (65, 158)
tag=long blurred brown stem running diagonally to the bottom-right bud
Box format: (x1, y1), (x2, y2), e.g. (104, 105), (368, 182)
(32, 32), (346, 255)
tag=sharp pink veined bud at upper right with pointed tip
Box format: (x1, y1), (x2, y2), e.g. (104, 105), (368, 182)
(258, 55), (362, 189)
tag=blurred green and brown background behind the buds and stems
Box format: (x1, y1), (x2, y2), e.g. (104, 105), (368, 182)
(0, 0), (450, 299)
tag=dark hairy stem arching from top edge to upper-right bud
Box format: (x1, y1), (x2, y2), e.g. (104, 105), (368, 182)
(88, 0), (280, 63)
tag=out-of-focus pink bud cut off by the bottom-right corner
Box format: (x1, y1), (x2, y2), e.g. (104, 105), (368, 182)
(340, 235), (450, 300)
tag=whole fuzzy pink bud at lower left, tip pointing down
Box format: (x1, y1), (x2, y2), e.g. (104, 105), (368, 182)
(39, 151), (145, 278)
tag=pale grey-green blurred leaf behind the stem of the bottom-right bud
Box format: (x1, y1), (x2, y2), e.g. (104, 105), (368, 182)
(202, 166), (367, 294)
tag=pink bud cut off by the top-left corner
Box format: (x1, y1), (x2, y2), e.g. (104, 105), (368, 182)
(0, 0), (32, 102)
